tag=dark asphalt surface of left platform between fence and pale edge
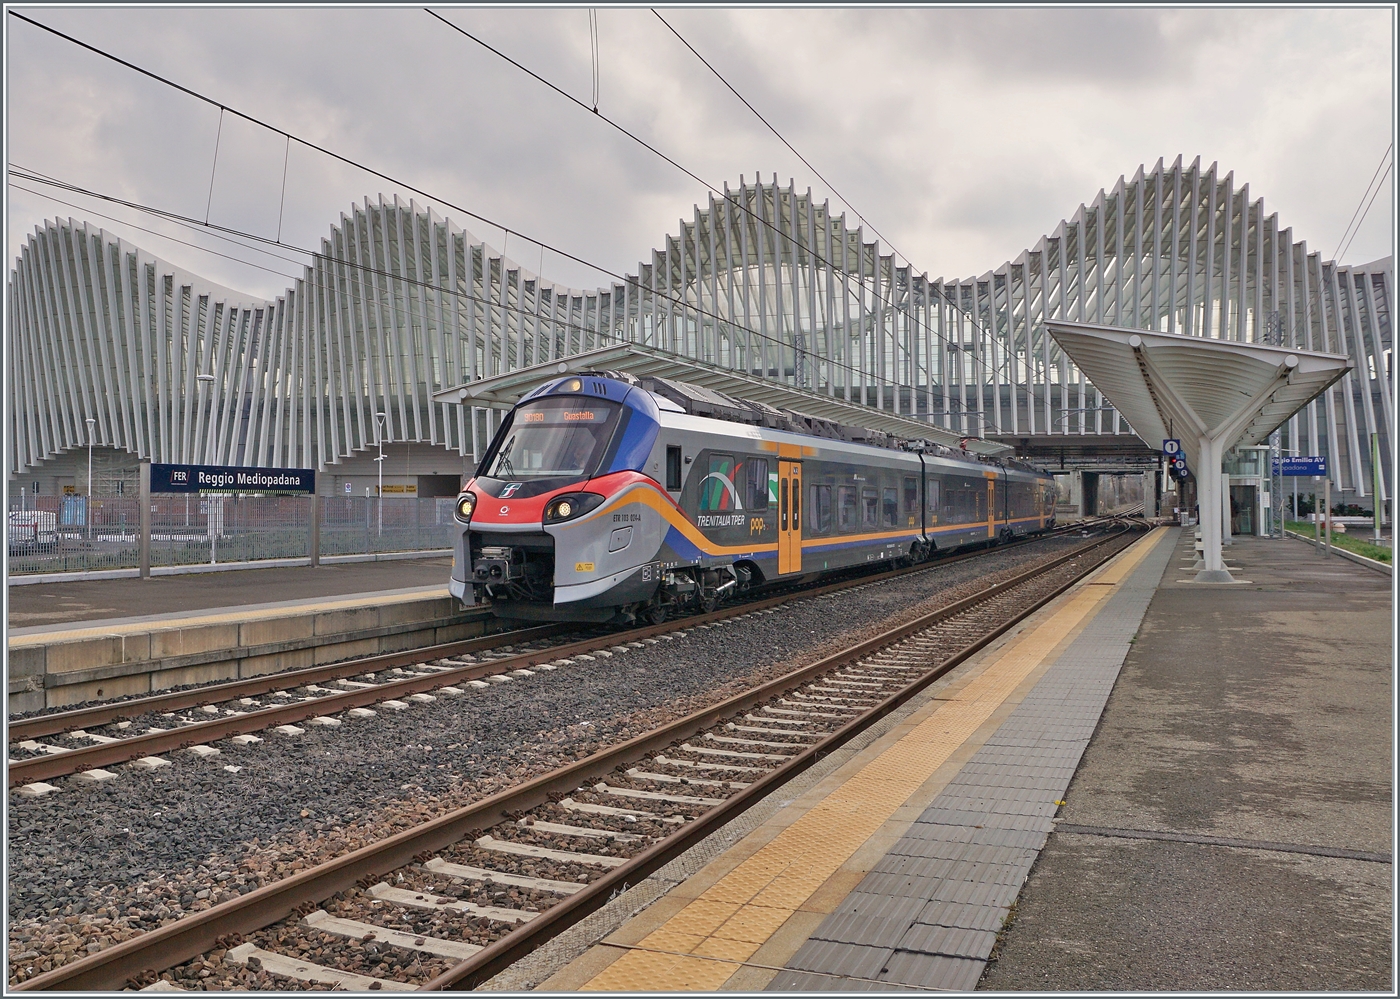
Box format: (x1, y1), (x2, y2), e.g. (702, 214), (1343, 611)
(7, 555), (452, 635)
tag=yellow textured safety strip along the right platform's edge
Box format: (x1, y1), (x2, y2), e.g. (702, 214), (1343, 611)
(581, 530), (1165, 992)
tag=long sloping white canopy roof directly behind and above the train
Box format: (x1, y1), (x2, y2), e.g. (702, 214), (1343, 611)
(433, 343), (1012, 455)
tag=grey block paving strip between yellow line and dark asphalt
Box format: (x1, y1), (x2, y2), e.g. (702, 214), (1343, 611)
(767, 526), (1173, 992)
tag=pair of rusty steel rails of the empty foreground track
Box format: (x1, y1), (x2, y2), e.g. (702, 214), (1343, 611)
(13, 530), (1128, 992)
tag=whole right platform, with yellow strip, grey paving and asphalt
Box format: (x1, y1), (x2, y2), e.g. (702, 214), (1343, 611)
(529, 527), (1392, 992)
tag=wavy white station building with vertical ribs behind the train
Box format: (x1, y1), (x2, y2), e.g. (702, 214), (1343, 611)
(6, 157), (1394, 517)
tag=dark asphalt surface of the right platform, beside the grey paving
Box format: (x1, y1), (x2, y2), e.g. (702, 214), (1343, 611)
(981, 536), (1396, 993)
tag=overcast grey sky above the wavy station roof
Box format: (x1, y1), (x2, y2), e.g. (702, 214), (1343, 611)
(6, 7), (1394, 295)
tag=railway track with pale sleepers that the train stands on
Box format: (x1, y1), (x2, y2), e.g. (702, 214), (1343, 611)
(7, 523), (1100, 795)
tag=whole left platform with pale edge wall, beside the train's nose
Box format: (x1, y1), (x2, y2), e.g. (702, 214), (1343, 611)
(6, 555), (487, 714)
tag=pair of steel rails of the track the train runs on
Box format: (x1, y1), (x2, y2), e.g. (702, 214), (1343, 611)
(6, 520), (1086, 789)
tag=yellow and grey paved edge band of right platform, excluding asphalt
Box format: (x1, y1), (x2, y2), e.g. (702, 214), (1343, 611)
(534, 530), (1177, 992)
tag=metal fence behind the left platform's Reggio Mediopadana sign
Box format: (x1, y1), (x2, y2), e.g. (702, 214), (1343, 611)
(7, 495), (455, 575)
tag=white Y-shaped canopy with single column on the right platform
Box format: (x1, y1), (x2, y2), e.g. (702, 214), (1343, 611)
(1046, 320), (1351, 582)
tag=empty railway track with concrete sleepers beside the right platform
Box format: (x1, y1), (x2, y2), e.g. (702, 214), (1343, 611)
(13, 520), (1138, 991)
